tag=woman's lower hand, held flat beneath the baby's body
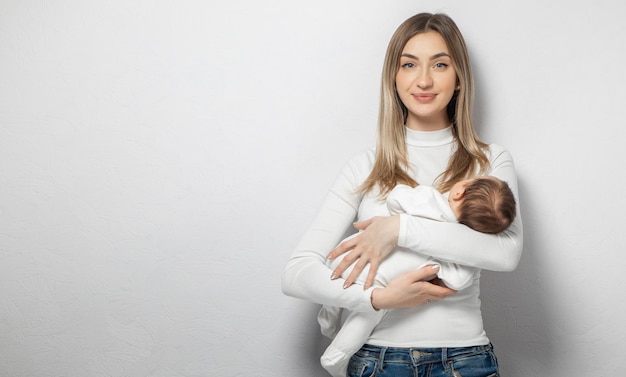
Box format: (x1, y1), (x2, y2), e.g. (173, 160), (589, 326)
(372, 265), (456, 310)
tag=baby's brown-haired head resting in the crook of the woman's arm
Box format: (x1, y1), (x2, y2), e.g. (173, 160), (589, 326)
(448, 176), (516, 233)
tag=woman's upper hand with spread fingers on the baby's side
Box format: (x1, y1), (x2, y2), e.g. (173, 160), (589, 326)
(328, 215), (400, 289)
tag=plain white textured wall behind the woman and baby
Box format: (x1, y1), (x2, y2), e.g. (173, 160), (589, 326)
(0, 0), (626, 377)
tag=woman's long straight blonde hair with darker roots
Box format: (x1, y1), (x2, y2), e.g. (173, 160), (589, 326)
(360, 13), (489, 197)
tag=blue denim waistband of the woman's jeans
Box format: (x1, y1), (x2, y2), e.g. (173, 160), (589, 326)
(358, 344), (493, 364)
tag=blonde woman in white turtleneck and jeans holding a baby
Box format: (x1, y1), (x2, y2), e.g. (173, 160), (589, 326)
(283, 13), (522, 377)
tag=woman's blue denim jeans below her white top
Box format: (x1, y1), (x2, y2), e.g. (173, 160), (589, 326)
(348, 344), (499, 377)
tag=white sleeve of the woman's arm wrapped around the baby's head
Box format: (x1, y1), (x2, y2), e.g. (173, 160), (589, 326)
(398, 145), (523, 271)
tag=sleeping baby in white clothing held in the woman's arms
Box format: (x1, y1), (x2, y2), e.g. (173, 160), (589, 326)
(318, 176), (516, 377)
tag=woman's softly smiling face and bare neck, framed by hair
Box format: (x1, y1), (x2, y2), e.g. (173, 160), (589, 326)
(396, 31), (457, 131)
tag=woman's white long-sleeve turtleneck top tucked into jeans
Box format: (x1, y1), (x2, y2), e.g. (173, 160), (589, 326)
(282, 128), (522, 347)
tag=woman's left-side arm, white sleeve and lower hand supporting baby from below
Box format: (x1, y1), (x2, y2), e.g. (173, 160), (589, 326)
(282, 149), (455, 312)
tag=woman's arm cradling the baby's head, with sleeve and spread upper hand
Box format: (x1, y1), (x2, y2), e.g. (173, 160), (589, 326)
(331, 145), (523, 287)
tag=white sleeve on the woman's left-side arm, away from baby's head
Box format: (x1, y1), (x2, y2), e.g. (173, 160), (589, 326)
(282, 151), (374, 312)
